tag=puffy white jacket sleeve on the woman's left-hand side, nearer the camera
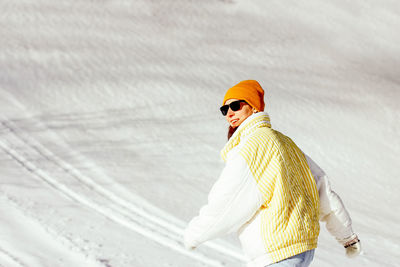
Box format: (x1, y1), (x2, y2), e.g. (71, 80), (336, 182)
(184, 150), (263, 248)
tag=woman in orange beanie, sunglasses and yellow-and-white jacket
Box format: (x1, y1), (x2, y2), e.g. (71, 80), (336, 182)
(184, 80), (361, 267)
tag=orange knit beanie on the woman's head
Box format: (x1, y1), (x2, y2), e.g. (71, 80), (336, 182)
(222, 80), (265, 111)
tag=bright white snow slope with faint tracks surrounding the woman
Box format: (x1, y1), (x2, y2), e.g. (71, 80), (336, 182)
(0, 0), (400, 267)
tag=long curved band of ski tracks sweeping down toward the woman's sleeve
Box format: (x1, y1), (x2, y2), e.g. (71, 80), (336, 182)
(0, 119), (244, 266)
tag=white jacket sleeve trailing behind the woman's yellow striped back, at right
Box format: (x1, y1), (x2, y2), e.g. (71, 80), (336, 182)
(306, 155), (356, 244)
